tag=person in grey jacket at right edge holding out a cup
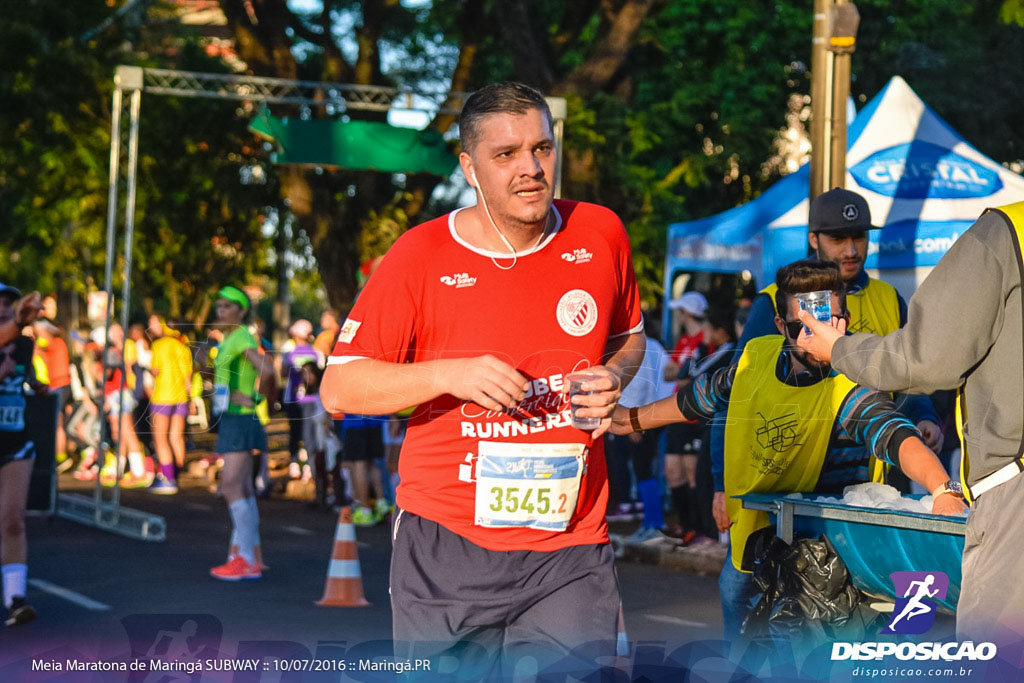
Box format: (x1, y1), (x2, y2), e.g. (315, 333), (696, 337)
(800, 203), (1024, 655)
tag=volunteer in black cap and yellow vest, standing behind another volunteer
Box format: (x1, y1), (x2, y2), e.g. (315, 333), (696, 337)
(711, 187), (942, 490)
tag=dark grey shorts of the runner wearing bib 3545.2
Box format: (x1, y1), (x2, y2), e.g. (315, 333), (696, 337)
(391, 510), (620, 680)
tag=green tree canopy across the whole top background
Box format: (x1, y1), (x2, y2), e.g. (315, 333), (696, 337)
(0, 0), (1024, 319)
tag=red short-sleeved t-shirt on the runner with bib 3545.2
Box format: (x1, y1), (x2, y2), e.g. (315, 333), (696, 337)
(329, 200), (643, 551)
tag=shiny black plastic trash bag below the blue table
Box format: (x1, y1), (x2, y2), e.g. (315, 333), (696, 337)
(743, 535), (880, 642)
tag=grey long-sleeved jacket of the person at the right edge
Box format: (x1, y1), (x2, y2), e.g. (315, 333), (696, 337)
(833, 212), (1024, 484)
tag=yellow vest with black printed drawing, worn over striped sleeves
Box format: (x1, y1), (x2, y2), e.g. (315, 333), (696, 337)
(724, 335), (856, 571)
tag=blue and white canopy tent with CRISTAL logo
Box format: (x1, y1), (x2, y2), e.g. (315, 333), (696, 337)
(665, 76), (1024, 300)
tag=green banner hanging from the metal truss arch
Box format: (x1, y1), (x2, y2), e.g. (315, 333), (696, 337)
(249, 113), (459, 176)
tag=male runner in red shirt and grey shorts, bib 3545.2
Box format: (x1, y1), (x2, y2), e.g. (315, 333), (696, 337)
(321, 83), (644, 677)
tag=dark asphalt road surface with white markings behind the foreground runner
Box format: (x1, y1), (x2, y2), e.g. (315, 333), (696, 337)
(0, 466), (721, 681)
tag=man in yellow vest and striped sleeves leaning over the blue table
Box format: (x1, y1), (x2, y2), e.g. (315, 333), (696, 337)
(612, 261), (964, 640)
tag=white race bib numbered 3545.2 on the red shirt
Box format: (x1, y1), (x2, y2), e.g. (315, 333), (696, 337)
(474, 441), (585, 531)
